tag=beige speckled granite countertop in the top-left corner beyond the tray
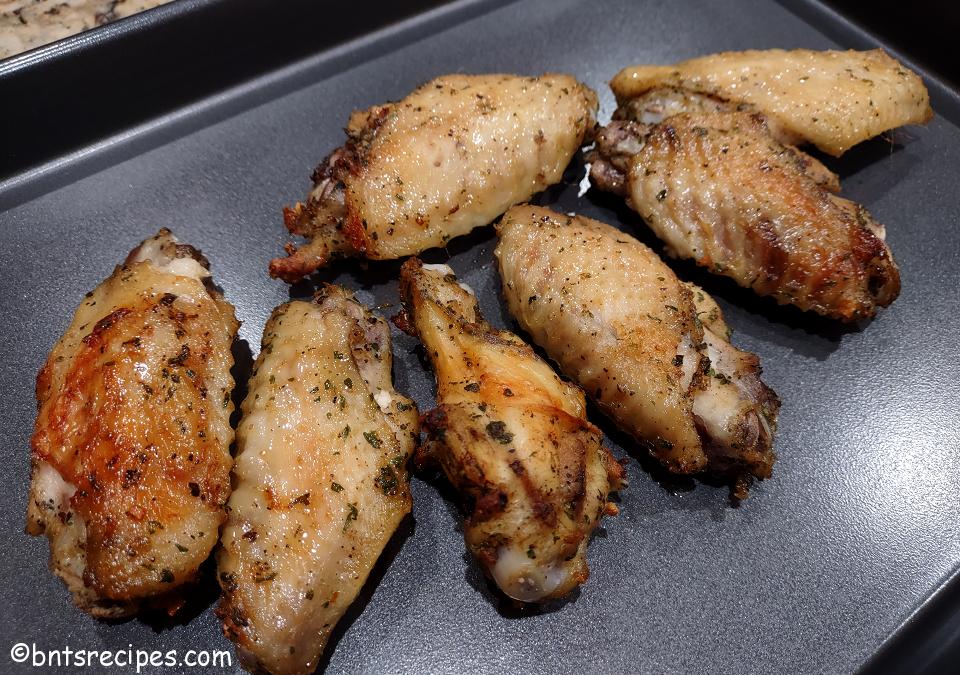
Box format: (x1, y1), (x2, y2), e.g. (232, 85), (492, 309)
(0, 0), (170, 59)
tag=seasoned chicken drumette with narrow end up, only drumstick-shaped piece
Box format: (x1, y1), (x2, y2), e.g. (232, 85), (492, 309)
(397, 258), (622, 602)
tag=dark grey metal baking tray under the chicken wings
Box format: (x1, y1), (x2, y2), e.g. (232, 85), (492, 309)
(0, 0), (960, 673)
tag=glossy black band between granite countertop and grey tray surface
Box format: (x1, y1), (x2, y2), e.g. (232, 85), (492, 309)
(0, 0), (454, 180)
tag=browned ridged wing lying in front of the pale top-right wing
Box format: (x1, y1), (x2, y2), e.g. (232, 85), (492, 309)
(590, 112), (900, 321)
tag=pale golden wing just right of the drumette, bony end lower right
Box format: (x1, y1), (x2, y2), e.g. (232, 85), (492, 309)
(495, 206), (779, 496)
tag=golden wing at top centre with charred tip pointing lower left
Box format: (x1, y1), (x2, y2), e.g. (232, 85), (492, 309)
(270, 75), (597, 282)
